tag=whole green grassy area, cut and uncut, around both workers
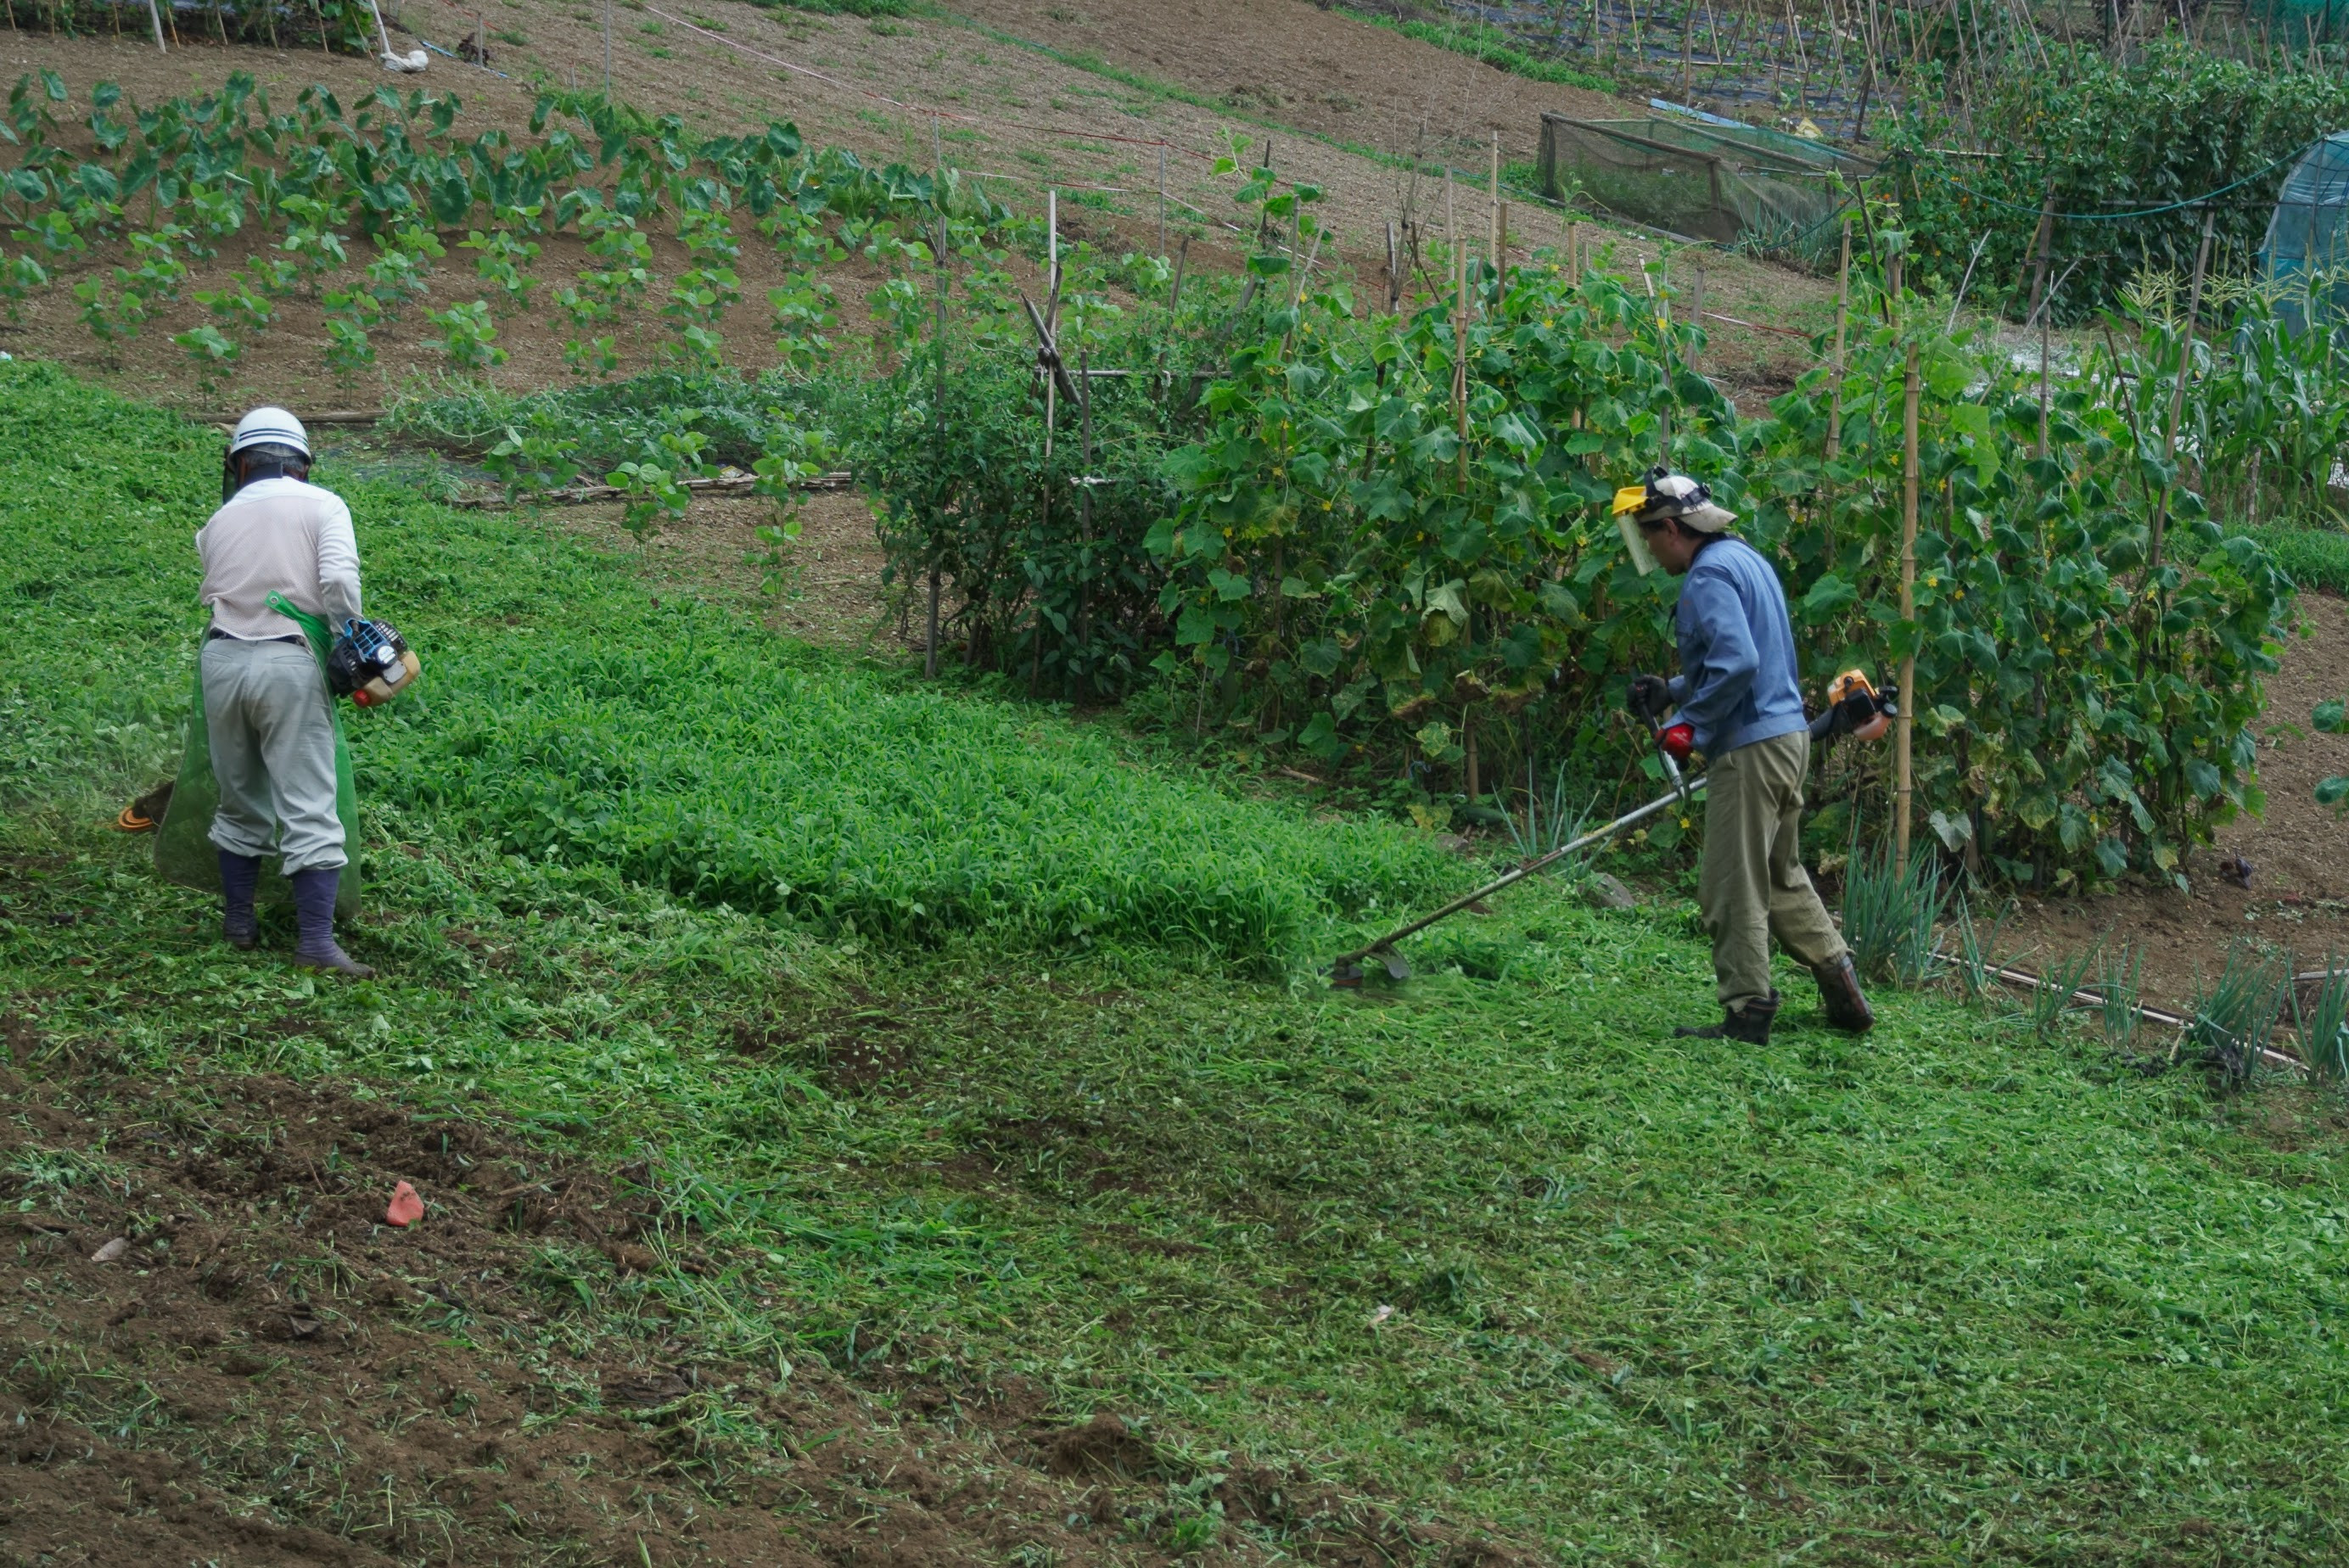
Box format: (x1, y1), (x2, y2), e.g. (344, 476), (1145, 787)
(14, 367), (2349, 1565)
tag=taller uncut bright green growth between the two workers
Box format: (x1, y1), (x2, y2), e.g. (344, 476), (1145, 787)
(0, 367), (1463, 965)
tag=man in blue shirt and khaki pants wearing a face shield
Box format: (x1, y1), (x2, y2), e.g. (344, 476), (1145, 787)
(1616, 468), (1875, 1044)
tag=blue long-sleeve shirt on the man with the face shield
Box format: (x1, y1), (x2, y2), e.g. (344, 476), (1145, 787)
(1670, 535), (1808, 756)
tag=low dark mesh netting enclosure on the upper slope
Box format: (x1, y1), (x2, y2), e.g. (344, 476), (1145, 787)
(1541, 113), (1870, 263)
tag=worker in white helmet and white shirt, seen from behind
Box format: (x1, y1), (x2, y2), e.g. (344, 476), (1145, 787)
(195, 408), (373, 979)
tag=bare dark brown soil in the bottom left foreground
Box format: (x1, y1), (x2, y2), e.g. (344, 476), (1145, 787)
(0, 1016), (1508, 1568)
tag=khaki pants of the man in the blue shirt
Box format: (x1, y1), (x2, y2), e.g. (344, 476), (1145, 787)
(1696, 730), (1844, 1011)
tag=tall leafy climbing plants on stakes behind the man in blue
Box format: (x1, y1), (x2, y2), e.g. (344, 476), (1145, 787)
(844, 166), (2292, 901)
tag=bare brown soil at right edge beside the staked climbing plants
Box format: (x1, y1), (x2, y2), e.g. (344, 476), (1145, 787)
(2001, 594), (2349, 1007)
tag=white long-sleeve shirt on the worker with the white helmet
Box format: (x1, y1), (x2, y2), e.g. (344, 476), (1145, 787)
(195, 477), (362, 641)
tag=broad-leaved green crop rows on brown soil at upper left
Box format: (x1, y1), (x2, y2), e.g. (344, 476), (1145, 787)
(0, 70), (1010, 401)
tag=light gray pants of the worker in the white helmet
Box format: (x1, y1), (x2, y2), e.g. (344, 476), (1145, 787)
(202, 636), (348, 876)
